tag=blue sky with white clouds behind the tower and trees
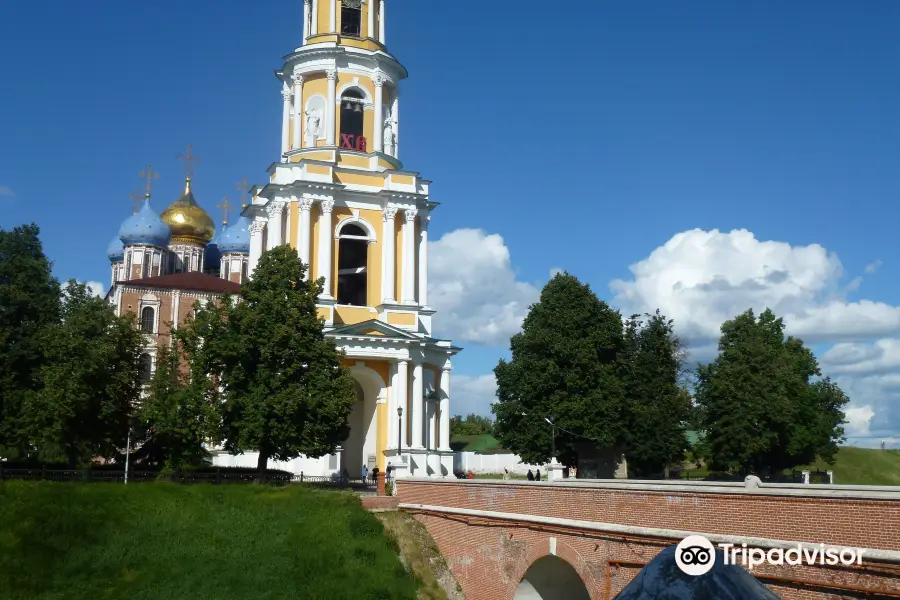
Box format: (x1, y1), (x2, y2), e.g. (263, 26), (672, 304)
(0, 0), (900, 447)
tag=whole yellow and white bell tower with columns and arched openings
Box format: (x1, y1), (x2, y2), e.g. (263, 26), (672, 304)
(243, 0), (460, 477)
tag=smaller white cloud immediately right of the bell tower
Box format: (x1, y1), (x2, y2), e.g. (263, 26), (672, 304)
(428, 229), (540, 346)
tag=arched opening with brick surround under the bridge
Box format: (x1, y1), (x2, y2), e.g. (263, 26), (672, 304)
(512, 537), (591, 600)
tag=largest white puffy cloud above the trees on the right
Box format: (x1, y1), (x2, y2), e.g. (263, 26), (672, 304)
(610, 229), (900, 344)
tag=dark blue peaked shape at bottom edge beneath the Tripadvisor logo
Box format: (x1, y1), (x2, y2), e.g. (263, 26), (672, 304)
(615, 546), (779, 600)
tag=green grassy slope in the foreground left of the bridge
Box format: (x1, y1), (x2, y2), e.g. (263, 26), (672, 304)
(0, 482), (419, 600)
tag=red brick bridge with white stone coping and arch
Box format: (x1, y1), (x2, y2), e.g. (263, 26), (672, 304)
(396, 479), (900, 600)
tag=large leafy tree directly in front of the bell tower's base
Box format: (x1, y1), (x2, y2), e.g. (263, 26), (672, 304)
(183, 246), (356, 480)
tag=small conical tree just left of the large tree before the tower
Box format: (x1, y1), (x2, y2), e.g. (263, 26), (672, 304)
(140, 332), (220, 471)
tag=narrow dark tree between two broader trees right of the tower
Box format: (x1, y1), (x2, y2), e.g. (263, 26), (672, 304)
(619, 310), (691, 477)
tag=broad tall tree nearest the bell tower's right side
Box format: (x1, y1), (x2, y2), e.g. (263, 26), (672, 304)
(492, 273), (625, 465)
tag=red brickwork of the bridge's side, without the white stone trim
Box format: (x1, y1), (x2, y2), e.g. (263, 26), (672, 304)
(398, 480), (900, 600)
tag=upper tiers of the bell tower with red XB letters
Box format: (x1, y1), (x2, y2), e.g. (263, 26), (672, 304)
(276, 0), (407, 169)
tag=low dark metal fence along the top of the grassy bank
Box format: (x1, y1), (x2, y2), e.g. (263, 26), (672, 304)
(0, 463), (376, 491)
